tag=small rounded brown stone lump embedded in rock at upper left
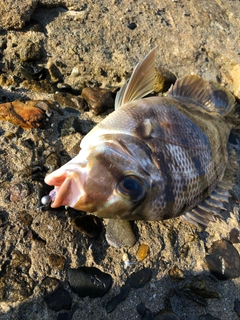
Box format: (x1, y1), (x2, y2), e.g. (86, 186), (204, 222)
(19, 40), (43, 62)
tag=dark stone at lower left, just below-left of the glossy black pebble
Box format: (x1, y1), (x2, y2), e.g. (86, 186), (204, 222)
(44, 288), (72, 311)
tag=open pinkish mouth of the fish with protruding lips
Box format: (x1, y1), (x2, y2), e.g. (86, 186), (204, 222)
(45, 166), (87, 208)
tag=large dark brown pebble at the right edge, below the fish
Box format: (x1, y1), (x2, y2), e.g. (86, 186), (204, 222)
(206, 240), (240, 280)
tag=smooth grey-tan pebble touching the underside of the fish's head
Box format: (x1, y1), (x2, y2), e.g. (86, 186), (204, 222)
(106, 219), (136, 249)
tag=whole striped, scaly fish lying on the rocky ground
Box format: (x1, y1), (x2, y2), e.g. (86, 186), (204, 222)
(45, 48), (239, 225)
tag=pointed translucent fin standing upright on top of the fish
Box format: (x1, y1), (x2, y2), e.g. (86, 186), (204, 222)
(115, 47), (157, 110)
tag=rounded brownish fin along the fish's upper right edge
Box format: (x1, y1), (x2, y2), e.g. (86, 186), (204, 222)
(168, 75), (235, 116)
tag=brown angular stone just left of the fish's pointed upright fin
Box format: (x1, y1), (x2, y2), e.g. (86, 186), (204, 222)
(82, 88), (114, 115)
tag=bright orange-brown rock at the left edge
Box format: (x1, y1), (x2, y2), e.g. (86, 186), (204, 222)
(0, 100), (52, 129)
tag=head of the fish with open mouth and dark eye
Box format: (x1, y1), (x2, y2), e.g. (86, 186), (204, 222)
(45, 134), (160, 220)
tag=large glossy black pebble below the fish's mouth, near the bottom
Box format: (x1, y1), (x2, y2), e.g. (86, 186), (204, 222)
(67, 266), (112, 298)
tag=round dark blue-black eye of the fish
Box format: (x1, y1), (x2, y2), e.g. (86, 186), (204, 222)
(117, 175), (146, 202)
